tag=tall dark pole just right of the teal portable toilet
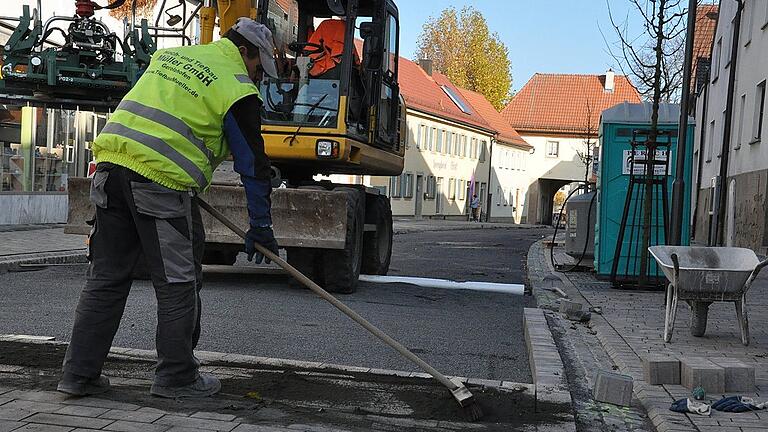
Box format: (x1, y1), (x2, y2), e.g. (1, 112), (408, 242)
(667, 0), (698, 245)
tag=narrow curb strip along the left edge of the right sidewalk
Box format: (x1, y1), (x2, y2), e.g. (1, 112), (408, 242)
(528, 241), (698, 431)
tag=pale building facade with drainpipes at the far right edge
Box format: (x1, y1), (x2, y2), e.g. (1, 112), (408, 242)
(692, 0), (768, 252)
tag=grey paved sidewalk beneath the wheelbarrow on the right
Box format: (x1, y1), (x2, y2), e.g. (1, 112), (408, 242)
(529, 242), (768, 432)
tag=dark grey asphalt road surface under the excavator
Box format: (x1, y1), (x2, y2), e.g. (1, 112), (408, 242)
(0, 229), (548, 382)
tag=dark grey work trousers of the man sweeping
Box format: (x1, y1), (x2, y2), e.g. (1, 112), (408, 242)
(63, 163), (205, 386)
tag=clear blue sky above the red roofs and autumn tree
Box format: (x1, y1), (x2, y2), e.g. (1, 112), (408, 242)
(397, 0), (637, 90)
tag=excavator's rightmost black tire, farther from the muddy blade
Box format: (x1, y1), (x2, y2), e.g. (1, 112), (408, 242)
(362, 194), (392, 275)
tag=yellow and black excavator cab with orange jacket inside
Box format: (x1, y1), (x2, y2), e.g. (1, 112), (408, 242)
(259, 0), (405, 180)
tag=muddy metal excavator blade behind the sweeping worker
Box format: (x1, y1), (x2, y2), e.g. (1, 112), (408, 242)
(64, 178), (348, 249)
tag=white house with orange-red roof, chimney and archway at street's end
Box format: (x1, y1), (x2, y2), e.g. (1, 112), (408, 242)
(502, 71), (640, 224)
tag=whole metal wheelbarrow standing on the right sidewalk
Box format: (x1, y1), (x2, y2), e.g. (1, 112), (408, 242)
(648, 246), (768, 345)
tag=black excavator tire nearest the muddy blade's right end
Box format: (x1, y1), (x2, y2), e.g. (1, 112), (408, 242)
(322, 187), (365, 294)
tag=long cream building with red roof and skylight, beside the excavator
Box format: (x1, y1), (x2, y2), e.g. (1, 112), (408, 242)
(371, 58), (531, 220)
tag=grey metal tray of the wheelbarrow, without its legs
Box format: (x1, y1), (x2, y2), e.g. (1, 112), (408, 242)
(648, 246), (760, 300)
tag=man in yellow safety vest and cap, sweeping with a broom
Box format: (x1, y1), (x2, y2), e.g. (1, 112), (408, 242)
(58, 18), (278, 398)
